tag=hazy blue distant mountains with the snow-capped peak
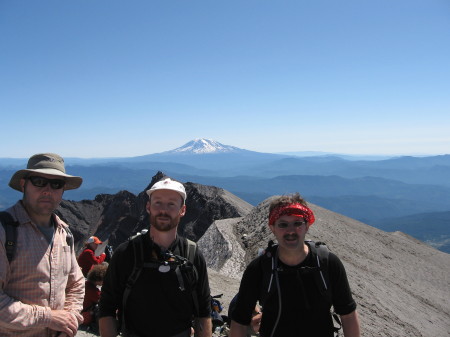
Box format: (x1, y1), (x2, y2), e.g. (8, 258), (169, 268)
(0, 139), (450, 252)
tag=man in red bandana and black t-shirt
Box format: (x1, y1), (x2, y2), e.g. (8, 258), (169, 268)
(230, 193), (360, 337)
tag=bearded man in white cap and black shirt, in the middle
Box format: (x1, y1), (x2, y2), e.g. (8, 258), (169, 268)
(99, 178), (212, 337)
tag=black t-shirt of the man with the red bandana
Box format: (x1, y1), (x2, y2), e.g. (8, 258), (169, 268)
(232, 242), (356, 337)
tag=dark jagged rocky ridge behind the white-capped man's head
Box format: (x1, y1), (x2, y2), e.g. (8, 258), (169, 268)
(56, 172), (253, 252)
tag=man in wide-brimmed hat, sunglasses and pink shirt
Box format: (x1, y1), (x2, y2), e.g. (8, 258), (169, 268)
(0, 153), (84, 337)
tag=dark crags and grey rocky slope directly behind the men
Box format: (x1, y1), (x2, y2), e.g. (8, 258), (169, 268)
(67, 172), (450, 337)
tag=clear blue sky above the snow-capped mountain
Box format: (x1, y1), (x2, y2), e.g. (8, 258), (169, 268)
(0, 0), (450, 157)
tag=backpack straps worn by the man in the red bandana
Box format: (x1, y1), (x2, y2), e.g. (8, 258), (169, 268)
(259, 240), (342, 336)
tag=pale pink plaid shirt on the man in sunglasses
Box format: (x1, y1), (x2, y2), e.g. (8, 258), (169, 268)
(0, 201), (84, 337)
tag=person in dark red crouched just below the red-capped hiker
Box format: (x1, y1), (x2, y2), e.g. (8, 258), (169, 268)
(81, 262), (108, 332)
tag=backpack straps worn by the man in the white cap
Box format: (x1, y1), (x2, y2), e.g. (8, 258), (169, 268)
(120, 235), (199, 332)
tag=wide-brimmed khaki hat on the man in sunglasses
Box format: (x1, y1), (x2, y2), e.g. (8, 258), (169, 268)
(9, 153), (83, 192)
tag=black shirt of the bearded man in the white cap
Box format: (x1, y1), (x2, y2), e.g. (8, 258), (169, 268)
(100, 235), (210, 337)
